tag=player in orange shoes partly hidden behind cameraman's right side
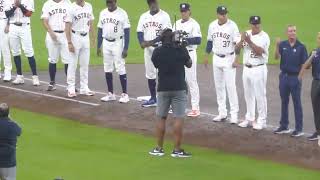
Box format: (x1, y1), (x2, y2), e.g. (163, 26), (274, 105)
(173, 3), (202, 117)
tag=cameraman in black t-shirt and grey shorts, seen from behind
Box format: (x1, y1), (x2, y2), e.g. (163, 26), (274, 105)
(149, 29), (192, 157)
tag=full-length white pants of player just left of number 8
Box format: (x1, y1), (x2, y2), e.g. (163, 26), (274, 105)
(67, 33), (90, 92)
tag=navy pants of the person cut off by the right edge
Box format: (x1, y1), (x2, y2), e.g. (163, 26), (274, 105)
(311, 79), (320, 136)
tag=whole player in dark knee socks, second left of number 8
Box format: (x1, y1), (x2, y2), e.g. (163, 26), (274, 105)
(41, 0), (70, 91)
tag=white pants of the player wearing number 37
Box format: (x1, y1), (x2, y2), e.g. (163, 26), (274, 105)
(213, 55), (239, 119)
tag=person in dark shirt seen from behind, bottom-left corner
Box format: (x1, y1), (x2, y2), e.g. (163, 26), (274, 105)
(0, 103), (21, 180)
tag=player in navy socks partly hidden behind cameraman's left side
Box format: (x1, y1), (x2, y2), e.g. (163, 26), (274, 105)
(137, 0), (172, 107)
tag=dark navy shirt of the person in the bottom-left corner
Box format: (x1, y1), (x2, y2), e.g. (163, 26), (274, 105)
(0, 118), (21, 168)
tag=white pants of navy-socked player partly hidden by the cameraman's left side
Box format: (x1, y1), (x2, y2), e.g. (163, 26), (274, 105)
(144, 47), (157, 79)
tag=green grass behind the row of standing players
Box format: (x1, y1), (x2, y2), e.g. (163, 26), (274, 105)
(13, 0), (320, 70)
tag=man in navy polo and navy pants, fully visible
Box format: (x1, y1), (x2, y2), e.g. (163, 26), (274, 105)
(274, 25), (308, 137)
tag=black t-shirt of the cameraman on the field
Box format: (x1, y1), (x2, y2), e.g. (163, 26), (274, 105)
(151, 45), (190, 92)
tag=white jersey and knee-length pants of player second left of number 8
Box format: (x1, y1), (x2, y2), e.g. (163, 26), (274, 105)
(41, 0), (70, 64)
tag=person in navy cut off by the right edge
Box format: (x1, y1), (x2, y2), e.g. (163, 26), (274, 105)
(299, 32), (320, 146)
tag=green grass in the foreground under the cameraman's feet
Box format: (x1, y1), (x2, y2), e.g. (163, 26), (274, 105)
(11, 109), (320, 180)
